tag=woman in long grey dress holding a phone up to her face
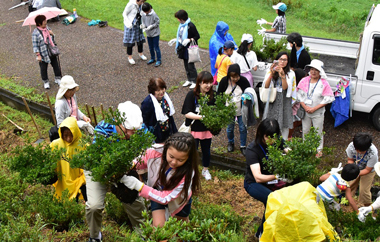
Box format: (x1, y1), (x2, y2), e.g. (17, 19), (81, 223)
(264, 51), (297, 140)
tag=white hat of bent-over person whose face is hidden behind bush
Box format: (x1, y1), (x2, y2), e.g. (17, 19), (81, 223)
(117, 101), (143, 129)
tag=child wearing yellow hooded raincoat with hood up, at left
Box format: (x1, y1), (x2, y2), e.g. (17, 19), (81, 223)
(50, 117), (86, 199)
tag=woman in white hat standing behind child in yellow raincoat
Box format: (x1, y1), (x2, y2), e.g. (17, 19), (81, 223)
(55, 75), (91, 127)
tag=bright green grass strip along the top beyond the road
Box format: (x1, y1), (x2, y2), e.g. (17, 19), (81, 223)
(61, 0), (376, 48)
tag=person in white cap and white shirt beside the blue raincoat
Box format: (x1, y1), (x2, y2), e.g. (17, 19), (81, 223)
(231, 34), (259, 88)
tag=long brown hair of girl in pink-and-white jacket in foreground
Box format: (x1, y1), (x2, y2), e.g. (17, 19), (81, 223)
(155, 132), (201, 204)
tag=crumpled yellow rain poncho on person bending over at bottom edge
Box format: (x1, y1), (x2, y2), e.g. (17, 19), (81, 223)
(260, 182), (340, 242)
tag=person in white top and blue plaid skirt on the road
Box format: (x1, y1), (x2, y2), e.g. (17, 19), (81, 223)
(123, 0), (147, 65)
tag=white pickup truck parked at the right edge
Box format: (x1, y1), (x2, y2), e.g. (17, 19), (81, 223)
(252, 4), (380, 131)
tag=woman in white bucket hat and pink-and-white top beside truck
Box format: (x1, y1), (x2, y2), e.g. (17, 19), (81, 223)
(297, 59), (335, 157)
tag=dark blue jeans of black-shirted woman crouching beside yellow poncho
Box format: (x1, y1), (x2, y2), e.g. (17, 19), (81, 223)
(244, 182), (272, 237)
